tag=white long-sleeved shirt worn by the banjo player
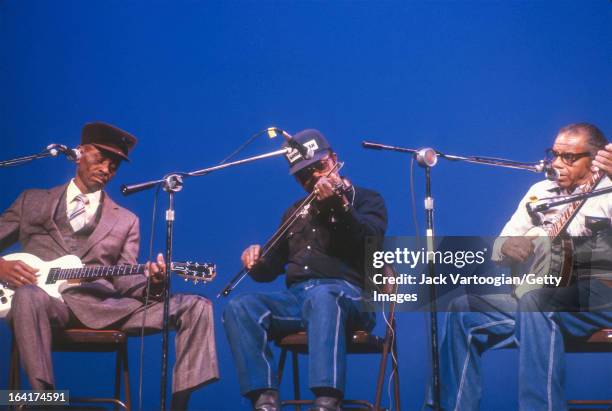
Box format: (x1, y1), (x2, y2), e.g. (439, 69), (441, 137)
(492, 176), (612, 261)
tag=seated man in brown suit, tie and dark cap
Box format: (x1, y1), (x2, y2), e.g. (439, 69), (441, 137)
(0, 122), (219, 409)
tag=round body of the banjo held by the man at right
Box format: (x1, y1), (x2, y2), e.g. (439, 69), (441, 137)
(512, 227), (574, 298)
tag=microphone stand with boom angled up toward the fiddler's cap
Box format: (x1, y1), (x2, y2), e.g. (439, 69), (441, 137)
(121, 148), (290, 411)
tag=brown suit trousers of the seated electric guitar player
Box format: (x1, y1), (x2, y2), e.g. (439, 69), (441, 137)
(9, 285), (219, 393)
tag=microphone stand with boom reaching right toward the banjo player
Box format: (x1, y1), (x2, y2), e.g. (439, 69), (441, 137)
(362, 141), (546, 411)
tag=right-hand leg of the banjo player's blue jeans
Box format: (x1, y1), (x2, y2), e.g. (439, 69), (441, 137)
(517, 280), (612, 411)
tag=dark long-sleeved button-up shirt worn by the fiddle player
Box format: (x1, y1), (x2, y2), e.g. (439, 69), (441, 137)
(251, 186), (387, 288)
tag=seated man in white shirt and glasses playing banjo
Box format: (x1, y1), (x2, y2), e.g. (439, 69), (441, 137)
(432, 123), (612, 410)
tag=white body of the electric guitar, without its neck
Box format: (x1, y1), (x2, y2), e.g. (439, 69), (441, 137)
(0, 253), (83, 318)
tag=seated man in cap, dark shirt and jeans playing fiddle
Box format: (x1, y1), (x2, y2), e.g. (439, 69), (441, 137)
(223, 130), (387, 411)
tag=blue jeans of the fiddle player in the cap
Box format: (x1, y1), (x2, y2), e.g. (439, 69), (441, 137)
(223, 279), (375, 395)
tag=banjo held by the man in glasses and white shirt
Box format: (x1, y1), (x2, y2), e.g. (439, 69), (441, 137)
(512, 170), (605, 298)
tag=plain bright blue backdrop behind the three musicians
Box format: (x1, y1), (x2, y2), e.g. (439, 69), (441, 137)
(0, 0), (612, 410)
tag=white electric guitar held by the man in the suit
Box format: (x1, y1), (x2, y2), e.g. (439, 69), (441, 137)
(0, 253), (217, 318)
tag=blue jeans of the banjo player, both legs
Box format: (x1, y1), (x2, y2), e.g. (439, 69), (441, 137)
(426, 281), (612, 411)
